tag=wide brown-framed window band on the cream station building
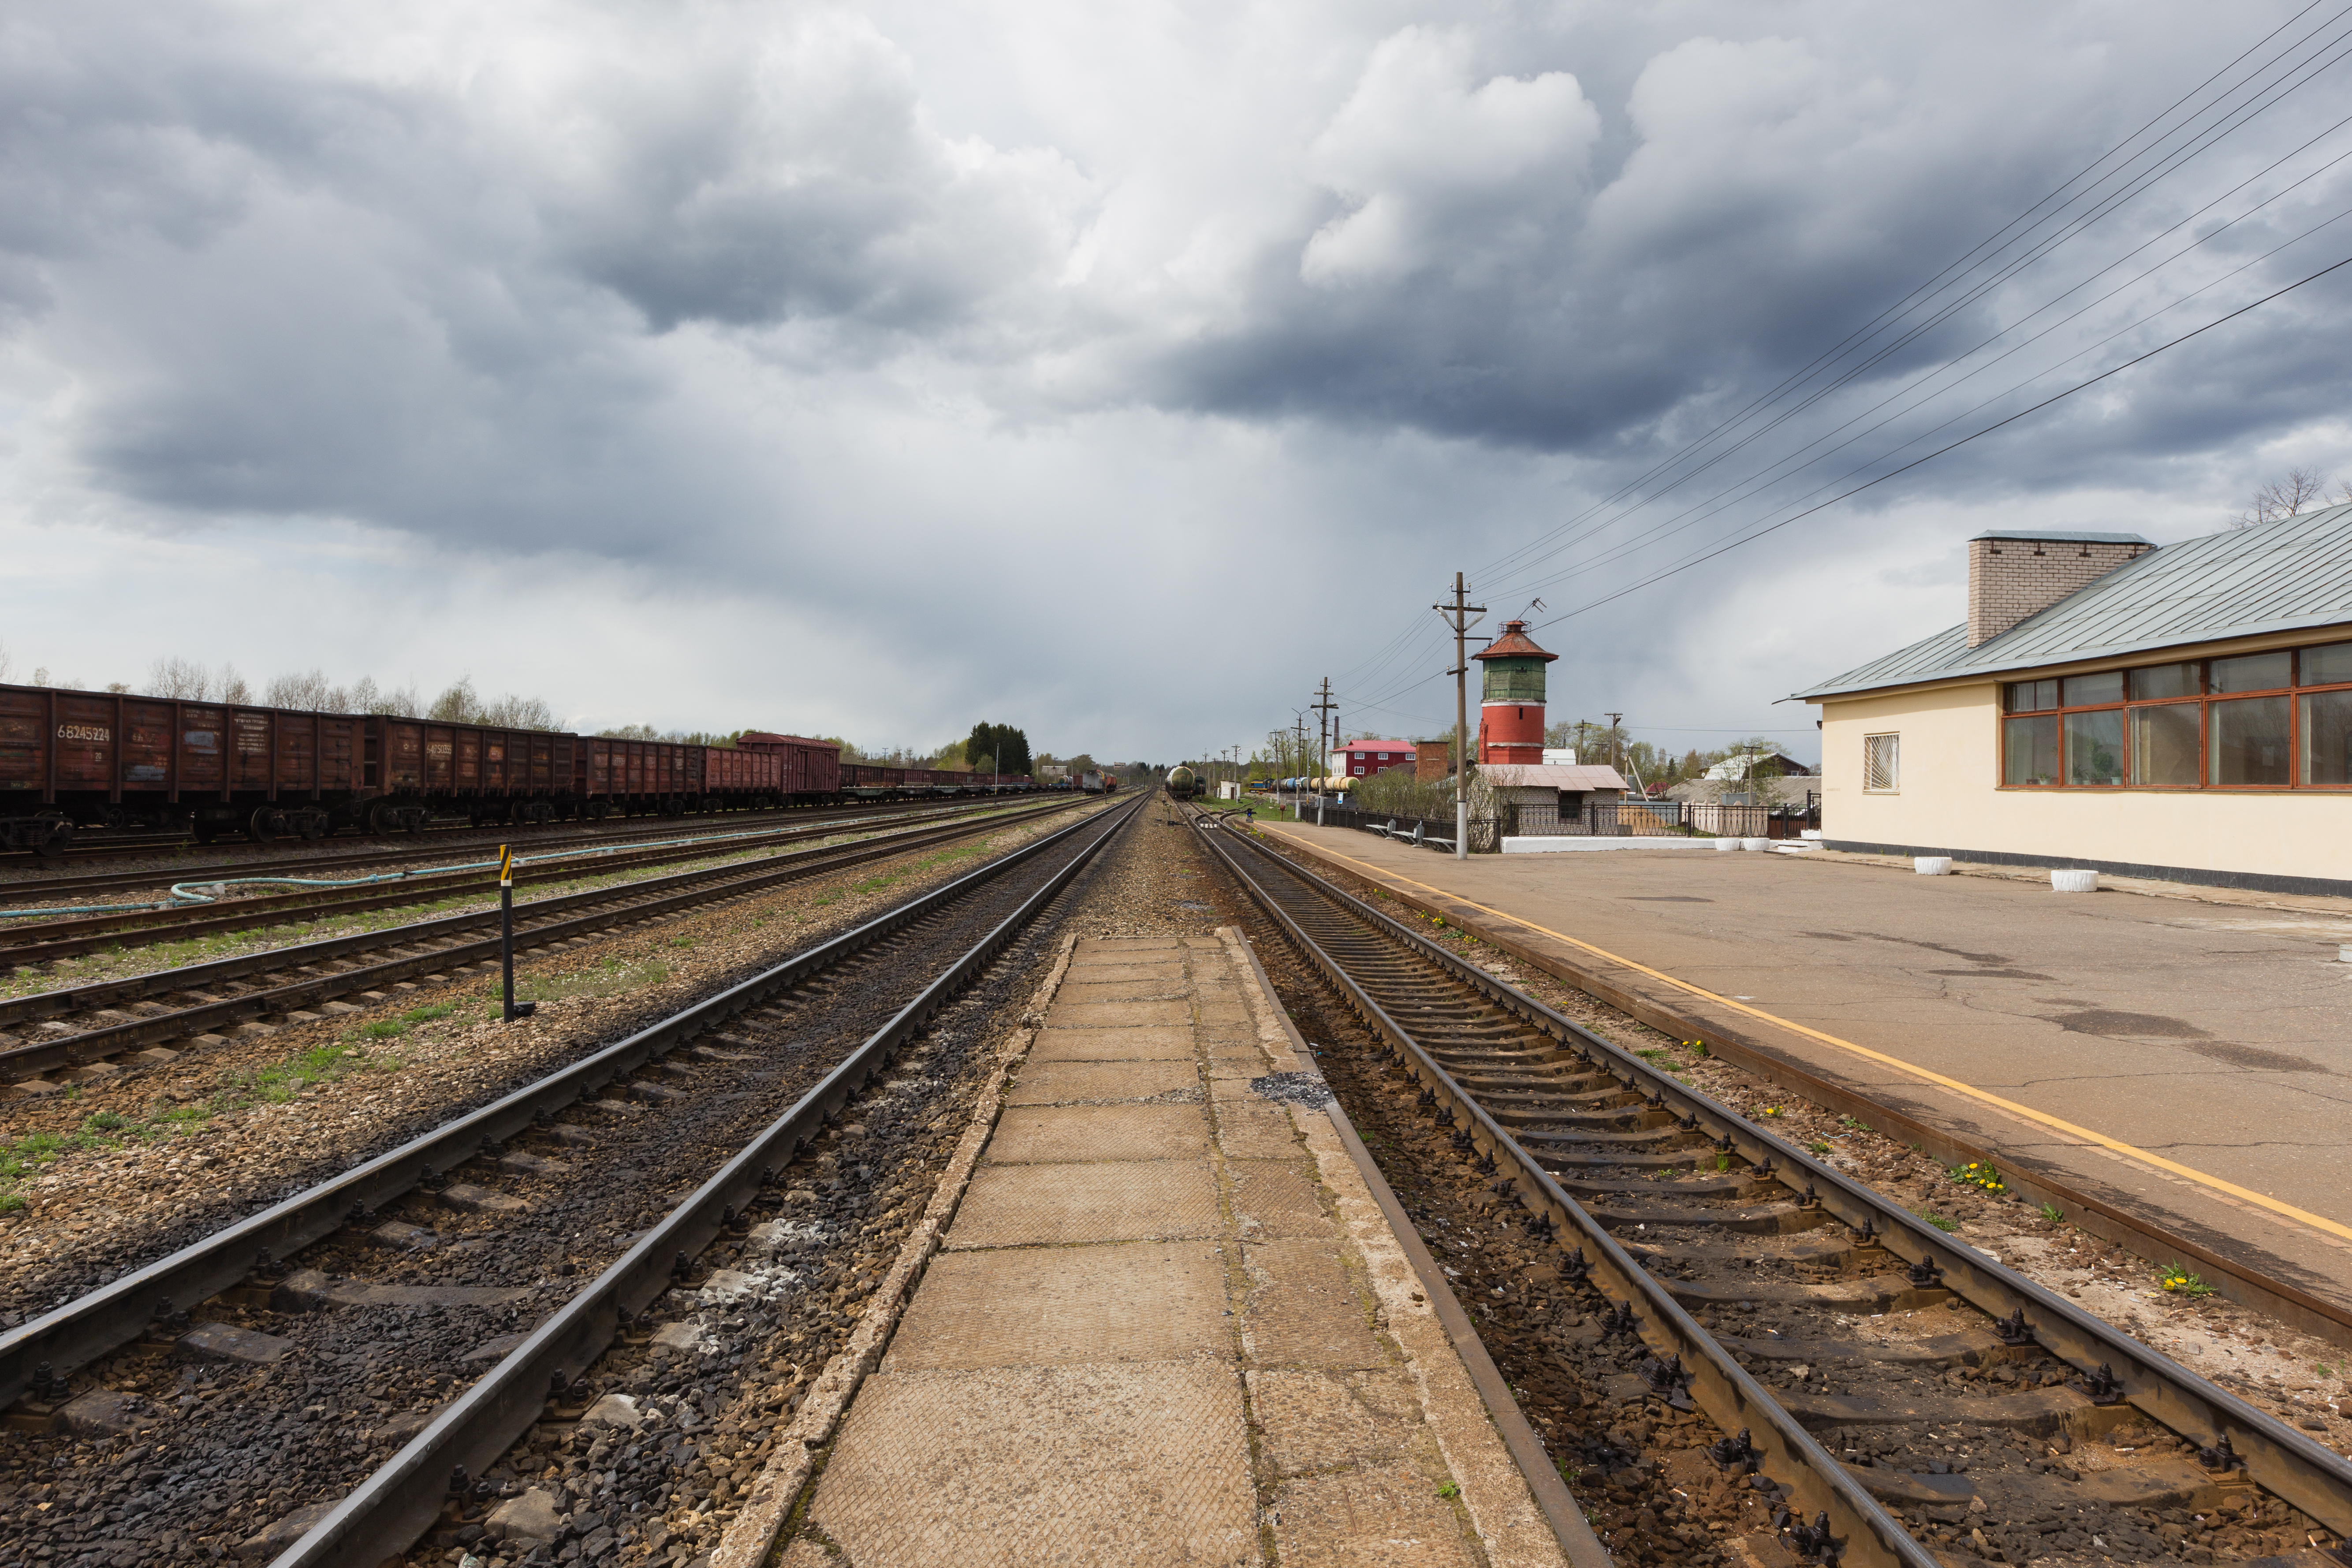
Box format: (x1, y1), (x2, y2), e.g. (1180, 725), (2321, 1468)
(2002, 642), (2352, 790)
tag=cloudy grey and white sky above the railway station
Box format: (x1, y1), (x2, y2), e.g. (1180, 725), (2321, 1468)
(0, 0), (2352, 760)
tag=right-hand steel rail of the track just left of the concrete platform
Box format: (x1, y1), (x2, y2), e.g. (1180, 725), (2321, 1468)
(271, 797), (1148, 1568)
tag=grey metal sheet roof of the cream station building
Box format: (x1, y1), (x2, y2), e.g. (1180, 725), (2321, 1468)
(1792, 506), (2352, 700)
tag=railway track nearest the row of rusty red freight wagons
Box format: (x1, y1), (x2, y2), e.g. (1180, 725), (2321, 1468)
(0, 799), (964, 903)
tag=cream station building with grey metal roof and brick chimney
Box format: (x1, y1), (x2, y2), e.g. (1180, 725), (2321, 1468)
(1795, 506), (2352, 893)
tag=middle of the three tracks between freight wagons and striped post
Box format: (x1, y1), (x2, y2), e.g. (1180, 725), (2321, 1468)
(0, 801), (1025, 964)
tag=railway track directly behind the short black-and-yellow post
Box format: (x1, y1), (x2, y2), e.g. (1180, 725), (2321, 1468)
(0, 799), (1077, 1095)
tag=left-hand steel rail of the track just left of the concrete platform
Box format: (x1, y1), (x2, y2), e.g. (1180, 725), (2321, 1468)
(0, 790), (1129, 1420)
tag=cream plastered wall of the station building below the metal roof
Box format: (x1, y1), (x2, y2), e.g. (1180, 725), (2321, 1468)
(1820, 682), (2352, 882)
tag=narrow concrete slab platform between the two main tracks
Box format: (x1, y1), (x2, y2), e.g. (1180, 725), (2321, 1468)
(713, 928), (1607, 1568)
